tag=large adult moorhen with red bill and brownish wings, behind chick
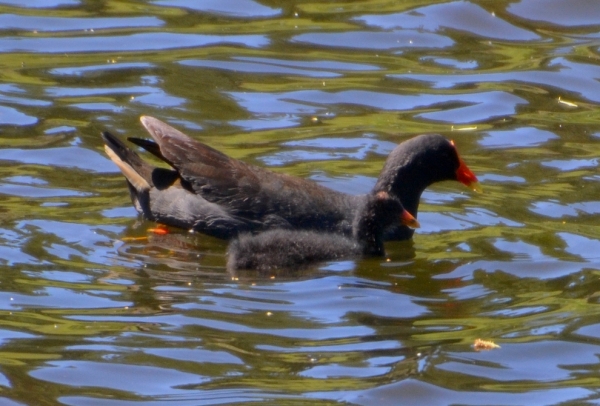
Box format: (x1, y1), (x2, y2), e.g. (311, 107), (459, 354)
(102, 116), (478, 240)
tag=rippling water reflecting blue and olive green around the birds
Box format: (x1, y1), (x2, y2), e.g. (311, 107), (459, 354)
(0, 0), (600, 406)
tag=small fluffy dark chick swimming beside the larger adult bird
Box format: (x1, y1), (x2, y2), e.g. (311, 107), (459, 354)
(227, 191), (419, 271)
